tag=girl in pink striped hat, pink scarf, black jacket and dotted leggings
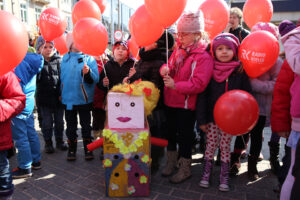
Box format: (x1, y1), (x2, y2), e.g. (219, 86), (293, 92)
(197, 33), (251, 192)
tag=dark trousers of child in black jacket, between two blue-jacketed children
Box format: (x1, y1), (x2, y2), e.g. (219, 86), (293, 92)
(39, 105), (64, 140)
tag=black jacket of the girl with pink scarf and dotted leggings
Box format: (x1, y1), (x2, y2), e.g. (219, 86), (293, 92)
(196, 69), (252, 126)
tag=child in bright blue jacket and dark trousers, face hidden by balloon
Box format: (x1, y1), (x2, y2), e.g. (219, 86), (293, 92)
(60, 33), (99, 161)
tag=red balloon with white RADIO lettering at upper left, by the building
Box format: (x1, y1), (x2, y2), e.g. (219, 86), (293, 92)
(39, 8), (67, 41)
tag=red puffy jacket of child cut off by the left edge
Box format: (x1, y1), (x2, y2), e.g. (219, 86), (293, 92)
(0, 72), (26, 151)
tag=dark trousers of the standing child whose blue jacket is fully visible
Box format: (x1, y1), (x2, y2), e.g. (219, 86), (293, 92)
(65, 104), (92, 141)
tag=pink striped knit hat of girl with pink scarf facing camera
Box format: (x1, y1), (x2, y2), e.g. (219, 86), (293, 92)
(212, 33), (240, 57)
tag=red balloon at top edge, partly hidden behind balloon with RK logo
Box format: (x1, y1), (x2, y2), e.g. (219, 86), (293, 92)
(72, 0), (101, 25)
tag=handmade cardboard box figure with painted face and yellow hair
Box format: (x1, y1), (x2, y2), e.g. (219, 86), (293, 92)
(88, 81), (166, 197)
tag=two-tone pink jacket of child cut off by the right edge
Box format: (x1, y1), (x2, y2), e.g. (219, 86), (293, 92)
(281, 27), (300, 132)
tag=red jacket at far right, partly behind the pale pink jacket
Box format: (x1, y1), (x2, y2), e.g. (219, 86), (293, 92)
(271, 60), (294, 133)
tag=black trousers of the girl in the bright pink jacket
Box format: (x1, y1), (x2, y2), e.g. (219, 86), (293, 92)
(166, 107), (195, 159)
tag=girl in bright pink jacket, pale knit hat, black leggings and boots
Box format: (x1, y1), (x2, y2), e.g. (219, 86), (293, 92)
(160, 10), (213, 183)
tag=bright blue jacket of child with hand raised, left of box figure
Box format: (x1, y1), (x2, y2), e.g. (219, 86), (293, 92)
(60, 52), (99, 110)
